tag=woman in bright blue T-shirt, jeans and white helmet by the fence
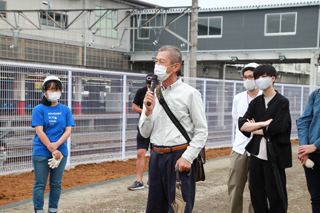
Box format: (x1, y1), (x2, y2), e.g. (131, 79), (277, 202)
(32, 76), (75, 213)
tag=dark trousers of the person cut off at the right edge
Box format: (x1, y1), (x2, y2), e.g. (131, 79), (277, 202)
(303, 154), (320, 213)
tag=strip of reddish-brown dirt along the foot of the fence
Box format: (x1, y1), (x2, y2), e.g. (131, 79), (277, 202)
(0, 147), (235, 206)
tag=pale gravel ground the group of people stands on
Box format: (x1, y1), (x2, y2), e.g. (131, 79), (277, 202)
(0, 146), (312, 213)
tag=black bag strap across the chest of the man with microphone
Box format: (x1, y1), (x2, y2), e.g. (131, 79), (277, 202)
(156, 87), (191, 143)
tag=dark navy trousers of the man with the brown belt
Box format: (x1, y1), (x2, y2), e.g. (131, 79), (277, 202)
(146, 147), (196, 213)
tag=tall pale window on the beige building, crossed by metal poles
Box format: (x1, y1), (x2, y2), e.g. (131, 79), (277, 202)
(95, 6), (118, 38)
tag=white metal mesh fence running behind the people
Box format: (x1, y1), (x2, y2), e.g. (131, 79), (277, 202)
(0, 62), (314, 174)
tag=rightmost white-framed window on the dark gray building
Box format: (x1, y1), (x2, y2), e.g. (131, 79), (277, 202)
(264, 12), (297, 36)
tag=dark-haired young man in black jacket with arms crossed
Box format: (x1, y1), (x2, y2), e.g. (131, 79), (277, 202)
(239, 65), (292, 213)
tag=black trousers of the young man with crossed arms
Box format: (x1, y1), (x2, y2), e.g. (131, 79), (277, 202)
(249, 155), (288, 213)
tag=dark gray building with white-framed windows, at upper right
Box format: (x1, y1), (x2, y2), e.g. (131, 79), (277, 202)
(130, 1), (320, 84)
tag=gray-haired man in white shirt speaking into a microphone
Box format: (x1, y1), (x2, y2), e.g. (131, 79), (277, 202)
(139, 46), (208, 213)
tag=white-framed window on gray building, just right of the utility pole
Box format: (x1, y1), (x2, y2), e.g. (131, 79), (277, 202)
(198, 16), (223, 38)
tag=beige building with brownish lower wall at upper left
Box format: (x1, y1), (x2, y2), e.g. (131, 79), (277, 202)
(0, 0), (155, 70)
